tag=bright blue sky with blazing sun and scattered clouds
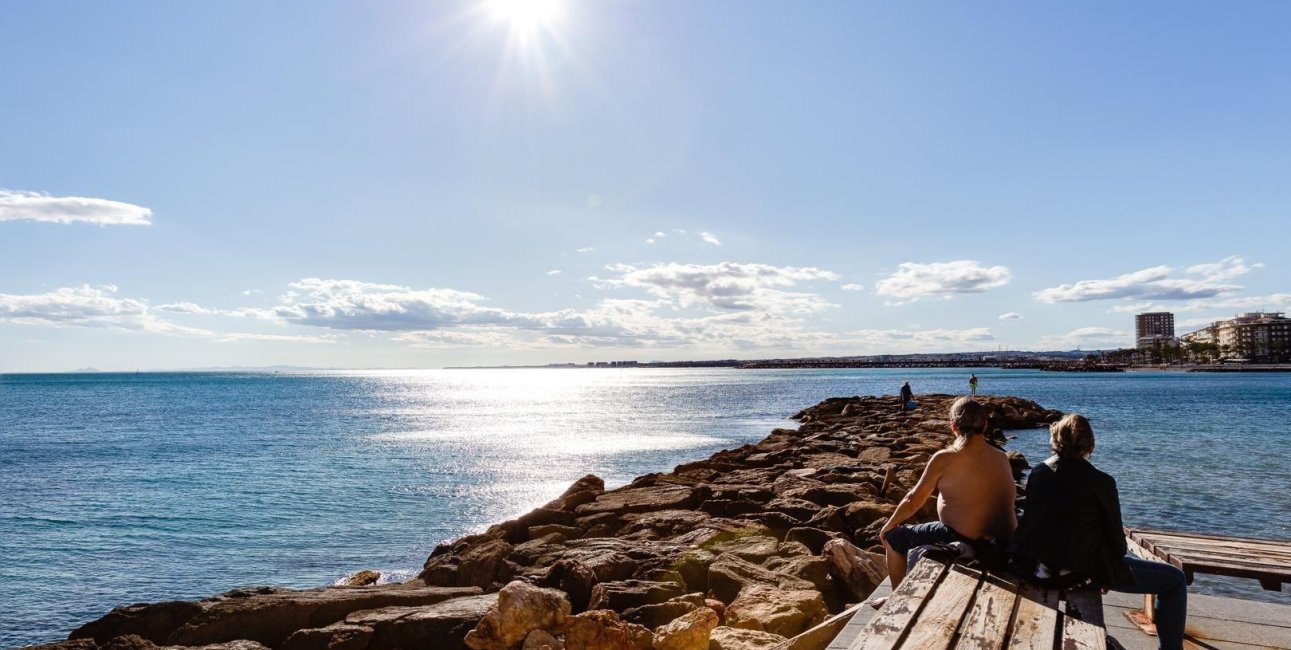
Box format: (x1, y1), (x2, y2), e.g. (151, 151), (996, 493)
(0, 0), (1291, 371)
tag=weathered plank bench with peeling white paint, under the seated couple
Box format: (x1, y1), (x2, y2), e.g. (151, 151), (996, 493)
(848, 558), (1108, 650)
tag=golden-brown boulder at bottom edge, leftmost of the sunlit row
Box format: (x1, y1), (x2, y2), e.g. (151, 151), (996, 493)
(465, 580), (569, 650)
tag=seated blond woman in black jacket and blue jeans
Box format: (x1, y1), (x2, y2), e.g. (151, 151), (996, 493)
(1010, 414), (1188, 650)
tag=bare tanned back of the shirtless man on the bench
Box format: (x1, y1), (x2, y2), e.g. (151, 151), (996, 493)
(928, 435), (1017, 539)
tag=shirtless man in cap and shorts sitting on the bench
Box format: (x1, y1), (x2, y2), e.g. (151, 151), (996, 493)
(879, 397), (1017, 589)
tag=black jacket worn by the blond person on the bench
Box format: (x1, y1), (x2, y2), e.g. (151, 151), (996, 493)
(1008, 456), (1135, 587)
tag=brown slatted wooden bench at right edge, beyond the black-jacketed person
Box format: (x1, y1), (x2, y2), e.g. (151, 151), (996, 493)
(1126, 529), (1291, 634)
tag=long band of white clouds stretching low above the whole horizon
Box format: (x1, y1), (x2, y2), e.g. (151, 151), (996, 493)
(0, 248), (1275, 364)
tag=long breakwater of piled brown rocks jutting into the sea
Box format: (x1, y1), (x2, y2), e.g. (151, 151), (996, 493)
(44, 395), (1060, 650)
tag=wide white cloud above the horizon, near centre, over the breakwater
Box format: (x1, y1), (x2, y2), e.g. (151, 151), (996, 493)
(593, 262), (839, 313)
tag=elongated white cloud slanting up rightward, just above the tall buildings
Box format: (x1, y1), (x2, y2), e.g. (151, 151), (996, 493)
(1035, 257), (1263, 302)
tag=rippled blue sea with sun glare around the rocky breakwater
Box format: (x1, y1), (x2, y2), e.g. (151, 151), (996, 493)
(0, 370), (1291, 647)
